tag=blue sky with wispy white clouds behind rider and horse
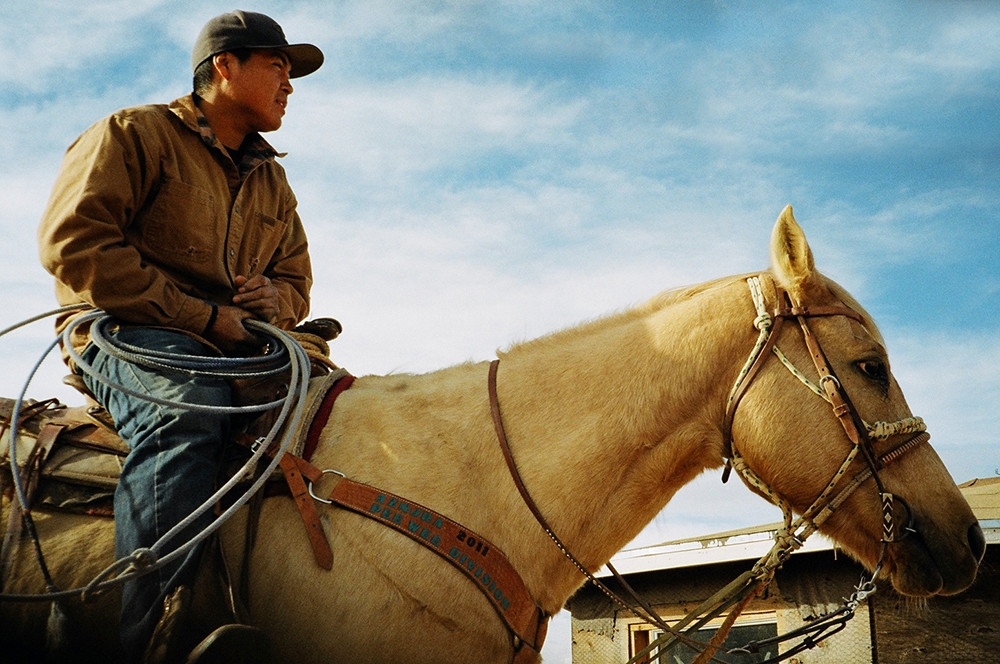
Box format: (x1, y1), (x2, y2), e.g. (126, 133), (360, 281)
(0, 0), (1000, 664)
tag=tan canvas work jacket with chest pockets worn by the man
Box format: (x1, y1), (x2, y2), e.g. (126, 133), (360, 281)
(38, 95), (312, 358)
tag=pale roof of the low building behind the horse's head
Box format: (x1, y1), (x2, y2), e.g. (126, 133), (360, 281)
(595, 477), (1000, 577)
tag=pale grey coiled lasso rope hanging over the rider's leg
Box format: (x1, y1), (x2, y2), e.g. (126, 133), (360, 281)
(0, 305), (310, 601)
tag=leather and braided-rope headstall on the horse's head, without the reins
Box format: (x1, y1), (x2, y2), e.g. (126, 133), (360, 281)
(722, 277), (930, 556)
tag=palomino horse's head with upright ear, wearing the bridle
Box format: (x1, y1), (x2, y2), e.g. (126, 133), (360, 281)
(732, 208), (985, 596)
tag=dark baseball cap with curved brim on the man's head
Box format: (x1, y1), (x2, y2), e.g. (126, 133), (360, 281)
(191, 10), (323, 78)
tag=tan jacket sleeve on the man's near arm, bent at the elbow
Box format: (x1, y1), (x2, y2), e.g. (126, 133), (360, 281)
(38, 115), (212, 333)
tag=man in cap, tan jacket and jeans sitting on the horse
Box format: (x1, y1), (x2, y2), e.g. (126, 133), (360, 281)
(39, 11), (323, 661)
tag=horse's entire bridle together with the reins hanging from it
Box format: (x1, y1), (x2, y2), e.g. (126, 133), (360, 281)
(488, 277), (930, 664)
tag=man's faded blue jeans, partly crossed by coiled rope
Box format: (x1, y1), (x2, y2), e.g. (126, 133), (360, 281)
(83, 327), (232, 661)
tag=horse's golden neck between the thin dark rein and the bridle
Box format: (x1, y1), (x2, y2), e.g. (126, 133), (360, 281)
(498, 282), (753, 600)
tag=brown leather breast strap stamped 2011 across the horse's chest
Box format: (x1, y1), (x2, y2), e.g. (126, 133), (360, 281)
(328, 475), (549, 663)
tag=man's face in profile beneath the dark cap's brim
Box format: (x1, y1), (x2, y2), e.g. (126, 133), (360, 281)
(228, 50), (292, 132)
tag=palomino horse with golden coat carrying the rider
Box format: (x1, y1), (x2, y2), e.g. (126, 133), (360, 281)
(2, 208), (985, 663)
